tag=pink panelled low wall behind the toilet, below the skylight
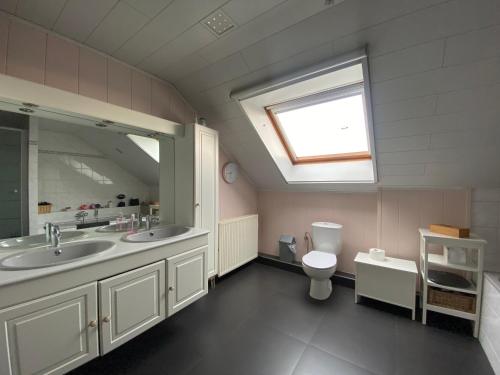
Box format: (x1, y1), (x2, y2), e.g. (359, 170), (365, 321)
(258, 190), (469, 273)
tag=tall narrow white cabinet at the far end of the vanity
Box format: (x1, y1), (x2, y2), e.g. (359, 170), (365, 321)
(167, 124), (219, 278)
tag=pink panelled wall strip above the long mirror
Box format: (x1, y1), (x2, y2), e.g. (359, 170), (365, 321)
(0, 12), (196, 123)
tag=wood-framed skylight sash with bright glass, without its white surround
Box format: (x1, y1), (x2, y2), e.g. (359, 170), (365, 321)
(266, 85), (371, 164)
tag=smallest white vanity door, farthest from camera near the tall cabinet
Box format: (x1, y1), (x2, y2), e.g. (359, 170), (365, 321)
(167, 246), (208, 316)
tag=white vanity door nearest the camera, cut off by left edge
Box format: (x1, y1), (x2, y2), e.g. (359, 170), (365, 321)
(0, 283), (99, 375)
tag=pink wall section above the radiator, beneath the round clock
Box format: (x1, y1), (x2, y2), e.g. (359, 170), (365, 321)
(219, 150), (257, 220)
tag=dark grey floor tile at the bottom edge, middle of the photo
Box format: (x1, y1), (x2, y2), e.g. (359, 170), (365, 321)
(188, 320), (306, 375)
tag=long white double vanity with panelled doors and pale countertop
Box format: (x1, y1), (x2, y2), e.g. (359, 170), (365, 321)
(0, 228), (208, 375)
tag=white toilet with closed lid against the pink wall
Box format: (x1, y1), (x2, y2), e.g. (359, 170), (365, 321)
(302, 222), (342, 300)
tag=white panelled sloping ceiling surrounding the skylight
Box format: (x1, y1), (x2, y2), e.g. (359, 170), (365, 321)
(176, 0), (500, 189)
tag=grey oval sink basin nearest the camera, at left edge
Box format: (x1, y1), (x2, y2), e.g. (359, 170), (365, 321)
(0, 241), (115, 270)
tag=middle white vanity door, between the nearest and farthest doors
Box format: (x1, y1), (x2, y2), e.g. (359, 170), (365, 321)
(99, 261), (165, 354)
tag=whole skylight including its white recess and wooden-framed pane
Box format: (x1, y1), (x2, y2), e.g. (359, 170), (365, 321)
(231, 48), (377, 185)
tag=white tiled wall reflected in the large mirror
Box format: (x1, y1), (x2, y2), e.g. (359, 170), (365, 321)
(38, 130), (150, 211)
